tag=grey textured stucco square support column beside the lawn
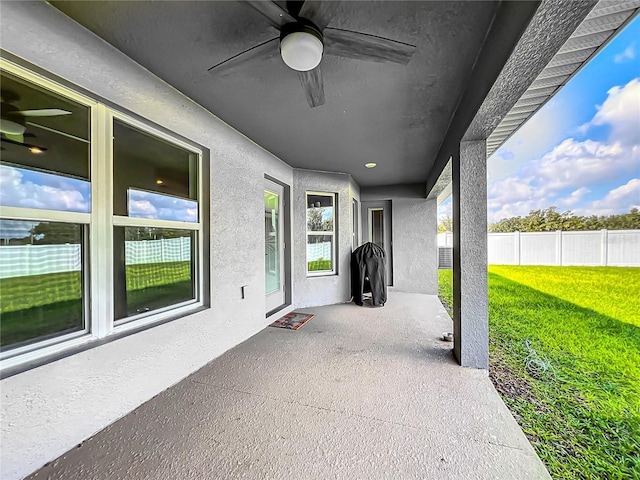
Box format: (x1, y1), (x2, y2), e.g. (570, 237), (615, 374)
(452, 140), (489, 369)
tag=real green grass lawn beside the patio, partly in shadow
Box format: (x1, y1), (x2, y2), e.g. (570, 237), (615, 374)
(439, 265), (640, 479)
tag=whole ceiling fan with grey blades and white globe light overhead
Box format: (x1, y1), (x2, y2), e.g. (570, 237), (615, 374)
(209, 0), (416, 107)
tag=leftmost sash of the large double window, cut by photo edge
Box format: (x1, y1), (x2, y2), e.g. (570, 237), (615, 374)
(0, 65), (92, 357)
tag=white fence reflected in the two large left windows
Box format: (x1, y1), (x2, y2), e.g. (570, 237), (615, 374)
(0, 237), (191, 278)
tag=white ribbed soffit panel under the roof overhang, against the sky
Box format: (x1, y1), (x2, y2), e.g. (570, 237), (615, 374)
(487, 0), (640, 157)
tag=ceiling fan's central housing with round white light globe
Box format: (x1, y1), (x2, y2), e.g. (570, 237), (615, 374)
(280, 19), (324, 72)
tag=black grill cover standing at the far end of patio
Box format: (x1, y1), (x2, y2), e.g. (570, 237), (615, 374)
(351, 242), (387, 306)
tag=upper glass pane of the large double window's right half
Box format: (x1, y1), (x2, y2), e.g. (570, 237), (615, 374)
(113, 120), (198, 222)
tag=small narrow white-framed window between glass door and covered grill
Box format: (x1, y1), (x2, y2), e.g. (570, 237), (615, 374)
(307, 192), (337, 275)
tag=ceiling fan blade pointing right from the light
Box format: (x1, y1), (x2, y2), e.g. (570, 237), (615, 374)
(323, 28), (416, 65)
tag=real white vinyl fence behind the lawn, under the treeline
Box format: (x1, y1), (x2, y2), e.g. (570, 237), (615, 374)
(438, 230), (640, 268)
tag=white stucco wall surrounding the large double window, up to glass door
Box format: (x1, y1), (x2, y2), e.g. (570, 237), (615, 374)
(0, 2), (295, 479)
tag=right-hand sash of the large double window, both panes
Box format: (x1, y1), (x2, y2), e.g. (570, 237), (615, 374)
(113, 119), (199, 322)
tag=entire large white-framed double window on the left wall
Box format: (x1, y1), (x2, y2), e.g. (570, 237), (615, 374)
(0, 60), (206, 369)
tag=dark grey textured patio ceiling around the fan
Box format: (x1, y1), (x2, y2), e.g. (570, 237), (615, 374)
(51, 1), (498, 186)
